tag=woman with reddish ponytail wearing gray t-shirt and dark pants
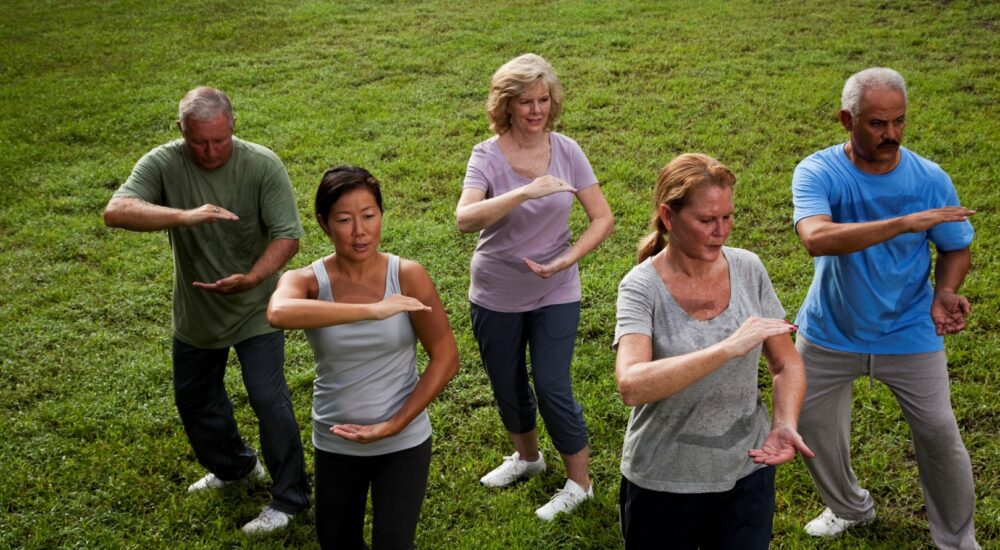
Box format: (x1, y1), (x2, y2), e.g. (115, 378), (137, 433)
(614, 154), (812, 549)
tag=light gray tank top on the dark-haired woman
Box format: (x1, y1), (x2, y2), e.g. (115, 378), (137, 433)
(305, 254), (431, 456)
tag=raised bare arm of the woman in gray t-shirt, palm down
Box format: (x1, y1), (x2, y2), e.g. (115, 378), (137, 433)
(615, 317), (795, 407)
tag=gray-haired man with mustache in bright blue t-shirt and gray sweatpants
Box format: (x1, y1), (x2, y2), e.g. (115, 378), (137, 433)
(792, 68), (979, 548)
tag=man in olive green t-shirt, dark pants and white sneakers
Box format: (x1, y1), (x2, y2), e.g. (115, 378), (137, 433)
(104, 87), (309, 534)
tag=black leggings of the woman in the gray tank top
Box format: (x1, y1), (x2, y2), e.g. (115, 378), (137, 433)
(316, 438), (431, 550)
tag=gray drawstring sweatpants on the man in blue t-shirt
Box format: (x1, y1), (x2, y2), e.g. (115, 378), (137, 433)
(795, 335), (979, 549)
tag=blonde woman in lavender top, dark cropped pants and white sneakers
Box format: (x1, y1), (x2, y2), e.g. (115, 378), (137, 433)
(455, 54), (614, 521)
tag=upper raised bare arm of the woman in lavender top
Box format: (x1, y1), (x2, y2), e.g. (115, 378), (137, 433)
(455, 176), (576, 233)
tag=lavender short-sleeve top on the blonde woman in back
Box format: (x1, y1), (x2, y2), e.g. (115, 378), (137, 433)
(463, 132), (597, 312)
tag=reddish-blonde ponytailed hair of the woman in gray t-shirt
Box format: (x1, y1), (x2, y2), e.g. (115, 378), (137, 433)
(636, 153), (736, 263)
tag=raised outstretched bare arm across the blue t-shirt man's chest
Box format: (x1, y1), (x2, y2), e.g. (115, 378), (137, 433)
(795, 206), (976, 256)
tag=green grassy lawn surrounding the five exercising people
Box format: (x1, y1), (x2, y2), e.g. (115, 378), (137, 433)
(0, 0), (1000, 549)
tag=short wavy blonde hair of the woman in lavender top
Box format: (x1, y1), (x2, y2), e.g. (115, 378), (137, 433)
(486, 53), (563, 135)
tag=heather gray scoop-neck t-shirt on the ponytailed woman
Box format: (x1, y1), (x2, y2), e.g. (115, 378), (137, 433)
(614, 247), (785, 493)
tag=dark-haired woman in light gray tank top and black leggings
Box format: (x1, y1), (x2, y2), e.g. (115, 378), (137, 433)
(267, 166), (458, 549)
